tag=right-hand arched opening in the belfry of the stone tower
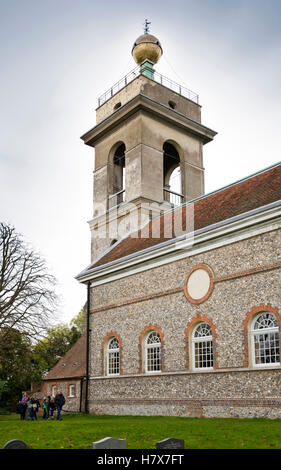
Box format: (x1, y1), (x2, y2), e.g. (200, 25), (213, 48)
(163, 142), (183, 205)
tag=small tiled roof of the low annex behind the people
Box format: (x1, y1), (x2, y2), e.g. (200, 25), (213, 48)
(43, 334), (86, 380)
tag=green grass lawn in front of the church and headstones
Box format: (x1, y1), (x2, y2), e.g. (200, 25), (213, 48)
(0, 414), (281, 449)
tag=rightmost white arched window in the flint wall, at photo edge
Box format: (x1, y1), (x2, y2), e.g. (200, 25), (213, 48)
(251, 312), (280, 366)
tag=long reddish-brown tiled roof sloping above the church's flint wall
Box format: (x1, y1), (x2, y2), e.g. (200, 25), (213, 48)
(81, 163), (281, 274)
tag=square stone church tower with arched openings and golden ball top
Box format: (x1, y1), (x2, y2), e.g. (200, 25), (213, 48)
(81, 21), (216, 261)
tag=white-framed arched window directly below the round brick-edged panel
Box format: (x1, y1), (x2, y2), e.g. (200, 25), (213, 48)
(192, 323), (214, 369)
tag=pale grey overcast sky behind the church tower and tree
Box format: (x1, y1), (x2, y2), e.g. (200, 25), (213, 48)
(0, 0), (281, 322)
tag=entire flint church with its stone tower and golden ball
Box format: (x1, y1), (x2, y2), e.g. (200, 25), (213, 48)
(77, 25), (281, 418)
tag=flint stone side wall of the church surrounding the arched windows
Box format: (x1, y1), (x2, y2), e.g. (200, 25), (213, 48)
(87, 230), (281, 418)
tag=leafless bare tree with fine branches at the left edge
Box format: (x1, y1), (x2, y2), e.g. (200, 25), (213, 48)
(0, 223), (57, 339)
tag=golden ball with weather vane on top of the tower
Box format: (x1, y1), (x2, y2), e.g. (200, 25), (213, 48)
(132, 20), (163, 65)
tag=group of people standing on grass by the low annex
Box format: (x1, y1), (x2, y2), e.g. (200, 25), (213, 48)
(18, 391), (65, 421)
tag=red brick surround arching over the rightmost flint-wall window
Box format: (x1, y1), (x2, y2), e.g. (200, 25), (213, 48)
(242, 303), (281, 367)
